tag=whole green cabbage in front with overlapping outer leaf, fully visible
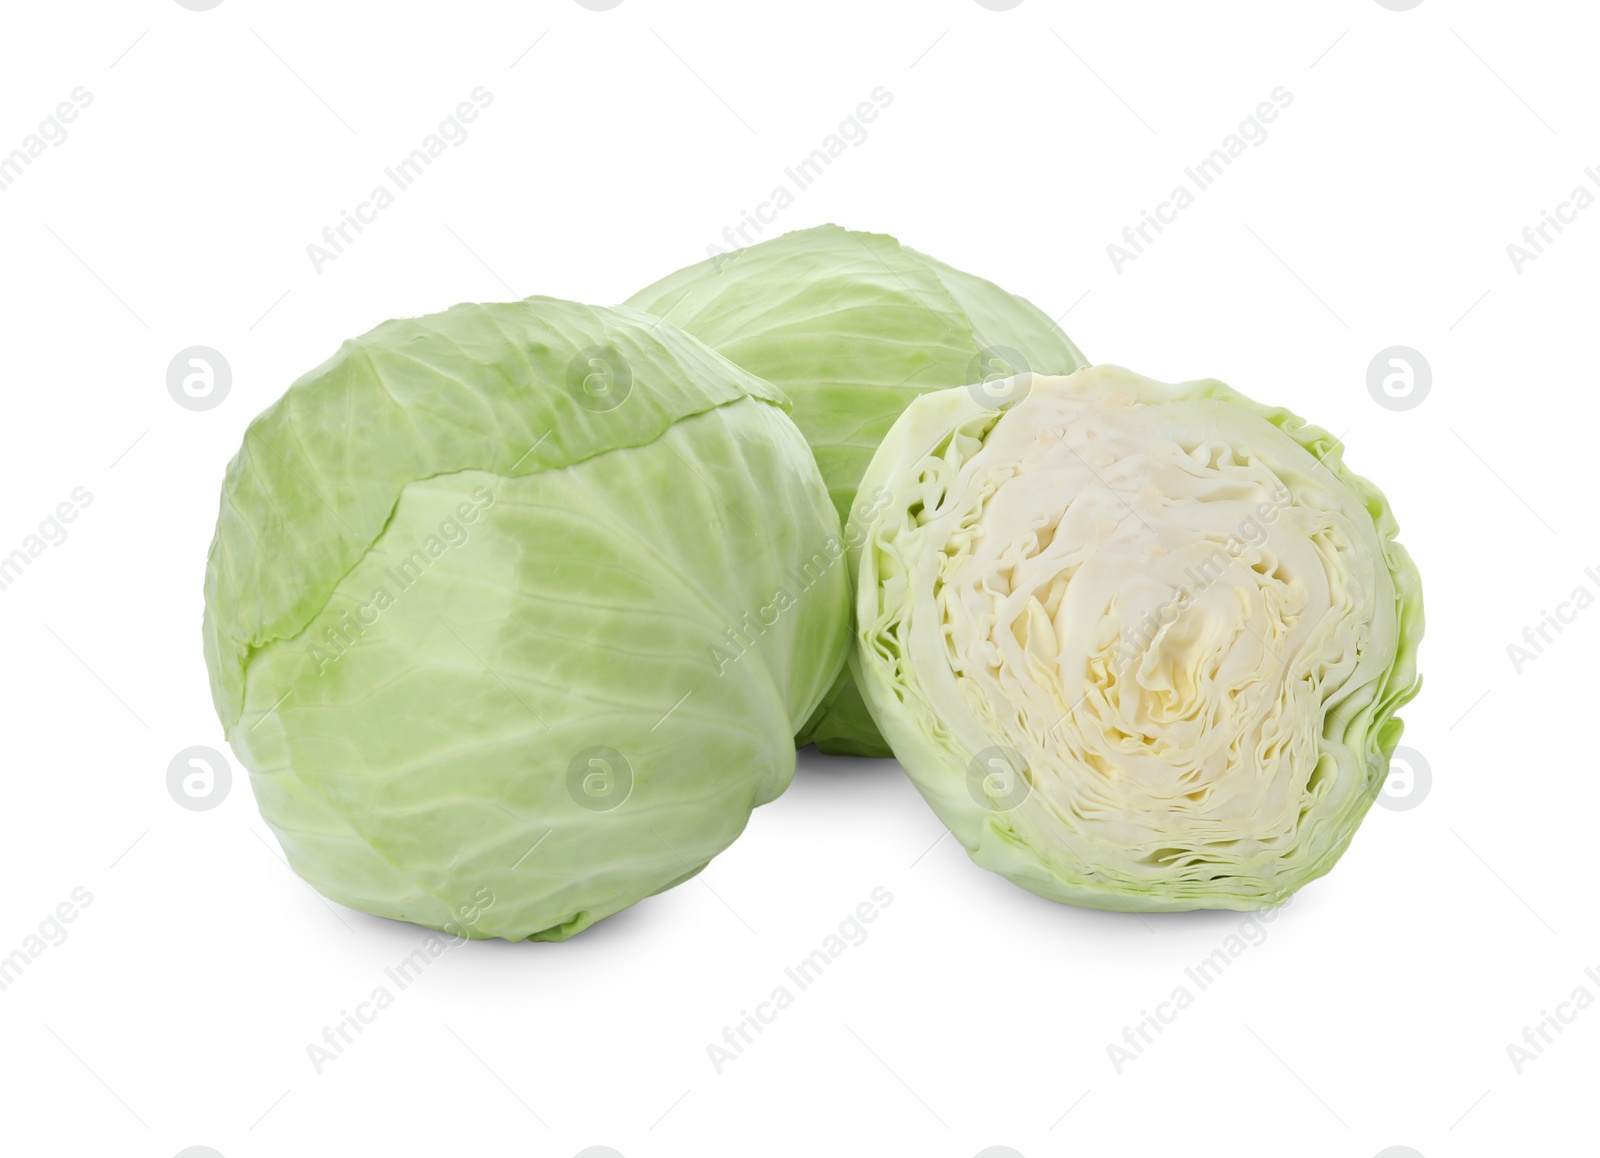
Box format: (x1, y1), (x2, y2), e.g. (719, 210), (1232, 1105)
(205, 299), (848, 940)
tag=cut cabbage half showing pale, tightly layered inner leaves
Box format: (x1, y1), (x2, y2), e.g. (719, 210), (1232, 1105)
(851, 366), (1422, 912)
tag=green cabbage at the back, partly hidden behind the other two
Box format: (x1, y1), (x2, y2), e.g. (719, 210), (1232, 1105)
(627, 226), (1086, 757)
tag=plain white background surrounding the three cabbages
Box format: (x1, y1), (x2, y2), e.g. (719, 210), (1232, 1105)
(0, 0), (1600, 1158)
